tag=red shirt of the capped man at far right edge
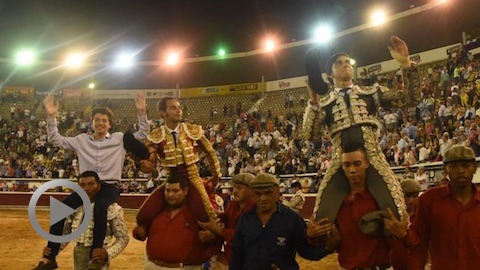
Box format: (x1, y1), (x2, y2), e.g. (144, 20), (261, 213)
(407, 185), (480, 270)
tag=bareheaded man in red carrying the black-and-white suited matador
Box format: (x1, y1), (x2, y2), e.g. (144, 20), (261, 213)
(309, 143), (393, 270)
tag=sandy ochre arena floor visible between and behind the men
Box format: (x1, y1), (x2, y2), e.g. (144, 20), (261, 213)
(0, 208), (338, 270)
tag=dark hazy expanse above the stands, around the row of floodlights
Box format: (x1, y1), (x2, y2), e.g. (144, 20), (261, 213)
(0, 0), (479, 90)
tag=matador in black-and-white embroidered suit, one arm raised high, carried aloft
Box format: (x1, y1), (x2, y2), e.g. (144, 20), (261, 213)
(303, 36), (421, 230)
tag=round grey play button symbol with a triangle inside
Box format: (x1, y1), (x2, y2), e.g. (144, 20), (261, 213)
(28, 179), (92, 243)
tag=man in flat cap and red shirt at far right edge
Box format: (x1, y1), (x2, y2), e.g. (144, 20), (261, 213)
(385, 145), (480, 270)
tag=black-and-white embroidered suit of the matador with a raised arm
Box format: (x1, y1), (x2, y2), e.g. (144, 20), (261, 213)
(303, 68), (421, 220)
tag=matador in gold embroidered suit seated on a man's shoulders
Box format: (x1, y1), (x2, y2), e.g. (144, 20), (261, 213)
(134, 97), (221, 236)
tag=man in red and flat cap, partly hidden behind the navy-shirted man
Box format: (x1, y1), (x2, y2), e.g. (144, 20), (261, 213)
(200, 173), (255, 265)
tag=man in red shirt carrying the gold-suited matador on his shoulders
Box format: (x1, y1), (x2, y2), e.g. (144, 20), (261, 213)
(133, 173), (217, 270)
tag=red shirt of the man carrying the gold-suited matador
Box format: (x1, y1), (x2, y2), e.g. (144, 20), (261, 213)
(147, 207), (215, 264)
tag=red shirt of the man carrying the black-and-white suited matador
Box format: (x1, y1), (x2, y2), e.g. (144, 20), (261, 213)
(337, 191), (390, 269)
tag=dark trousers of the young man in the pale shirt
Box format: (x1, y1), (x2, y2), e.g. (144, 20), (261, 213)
(44, 182), (120, 260)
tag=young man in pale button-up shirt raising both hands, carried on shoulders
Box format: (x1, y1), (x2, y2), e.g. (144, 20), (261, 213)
(34, 93), (150, 270)
